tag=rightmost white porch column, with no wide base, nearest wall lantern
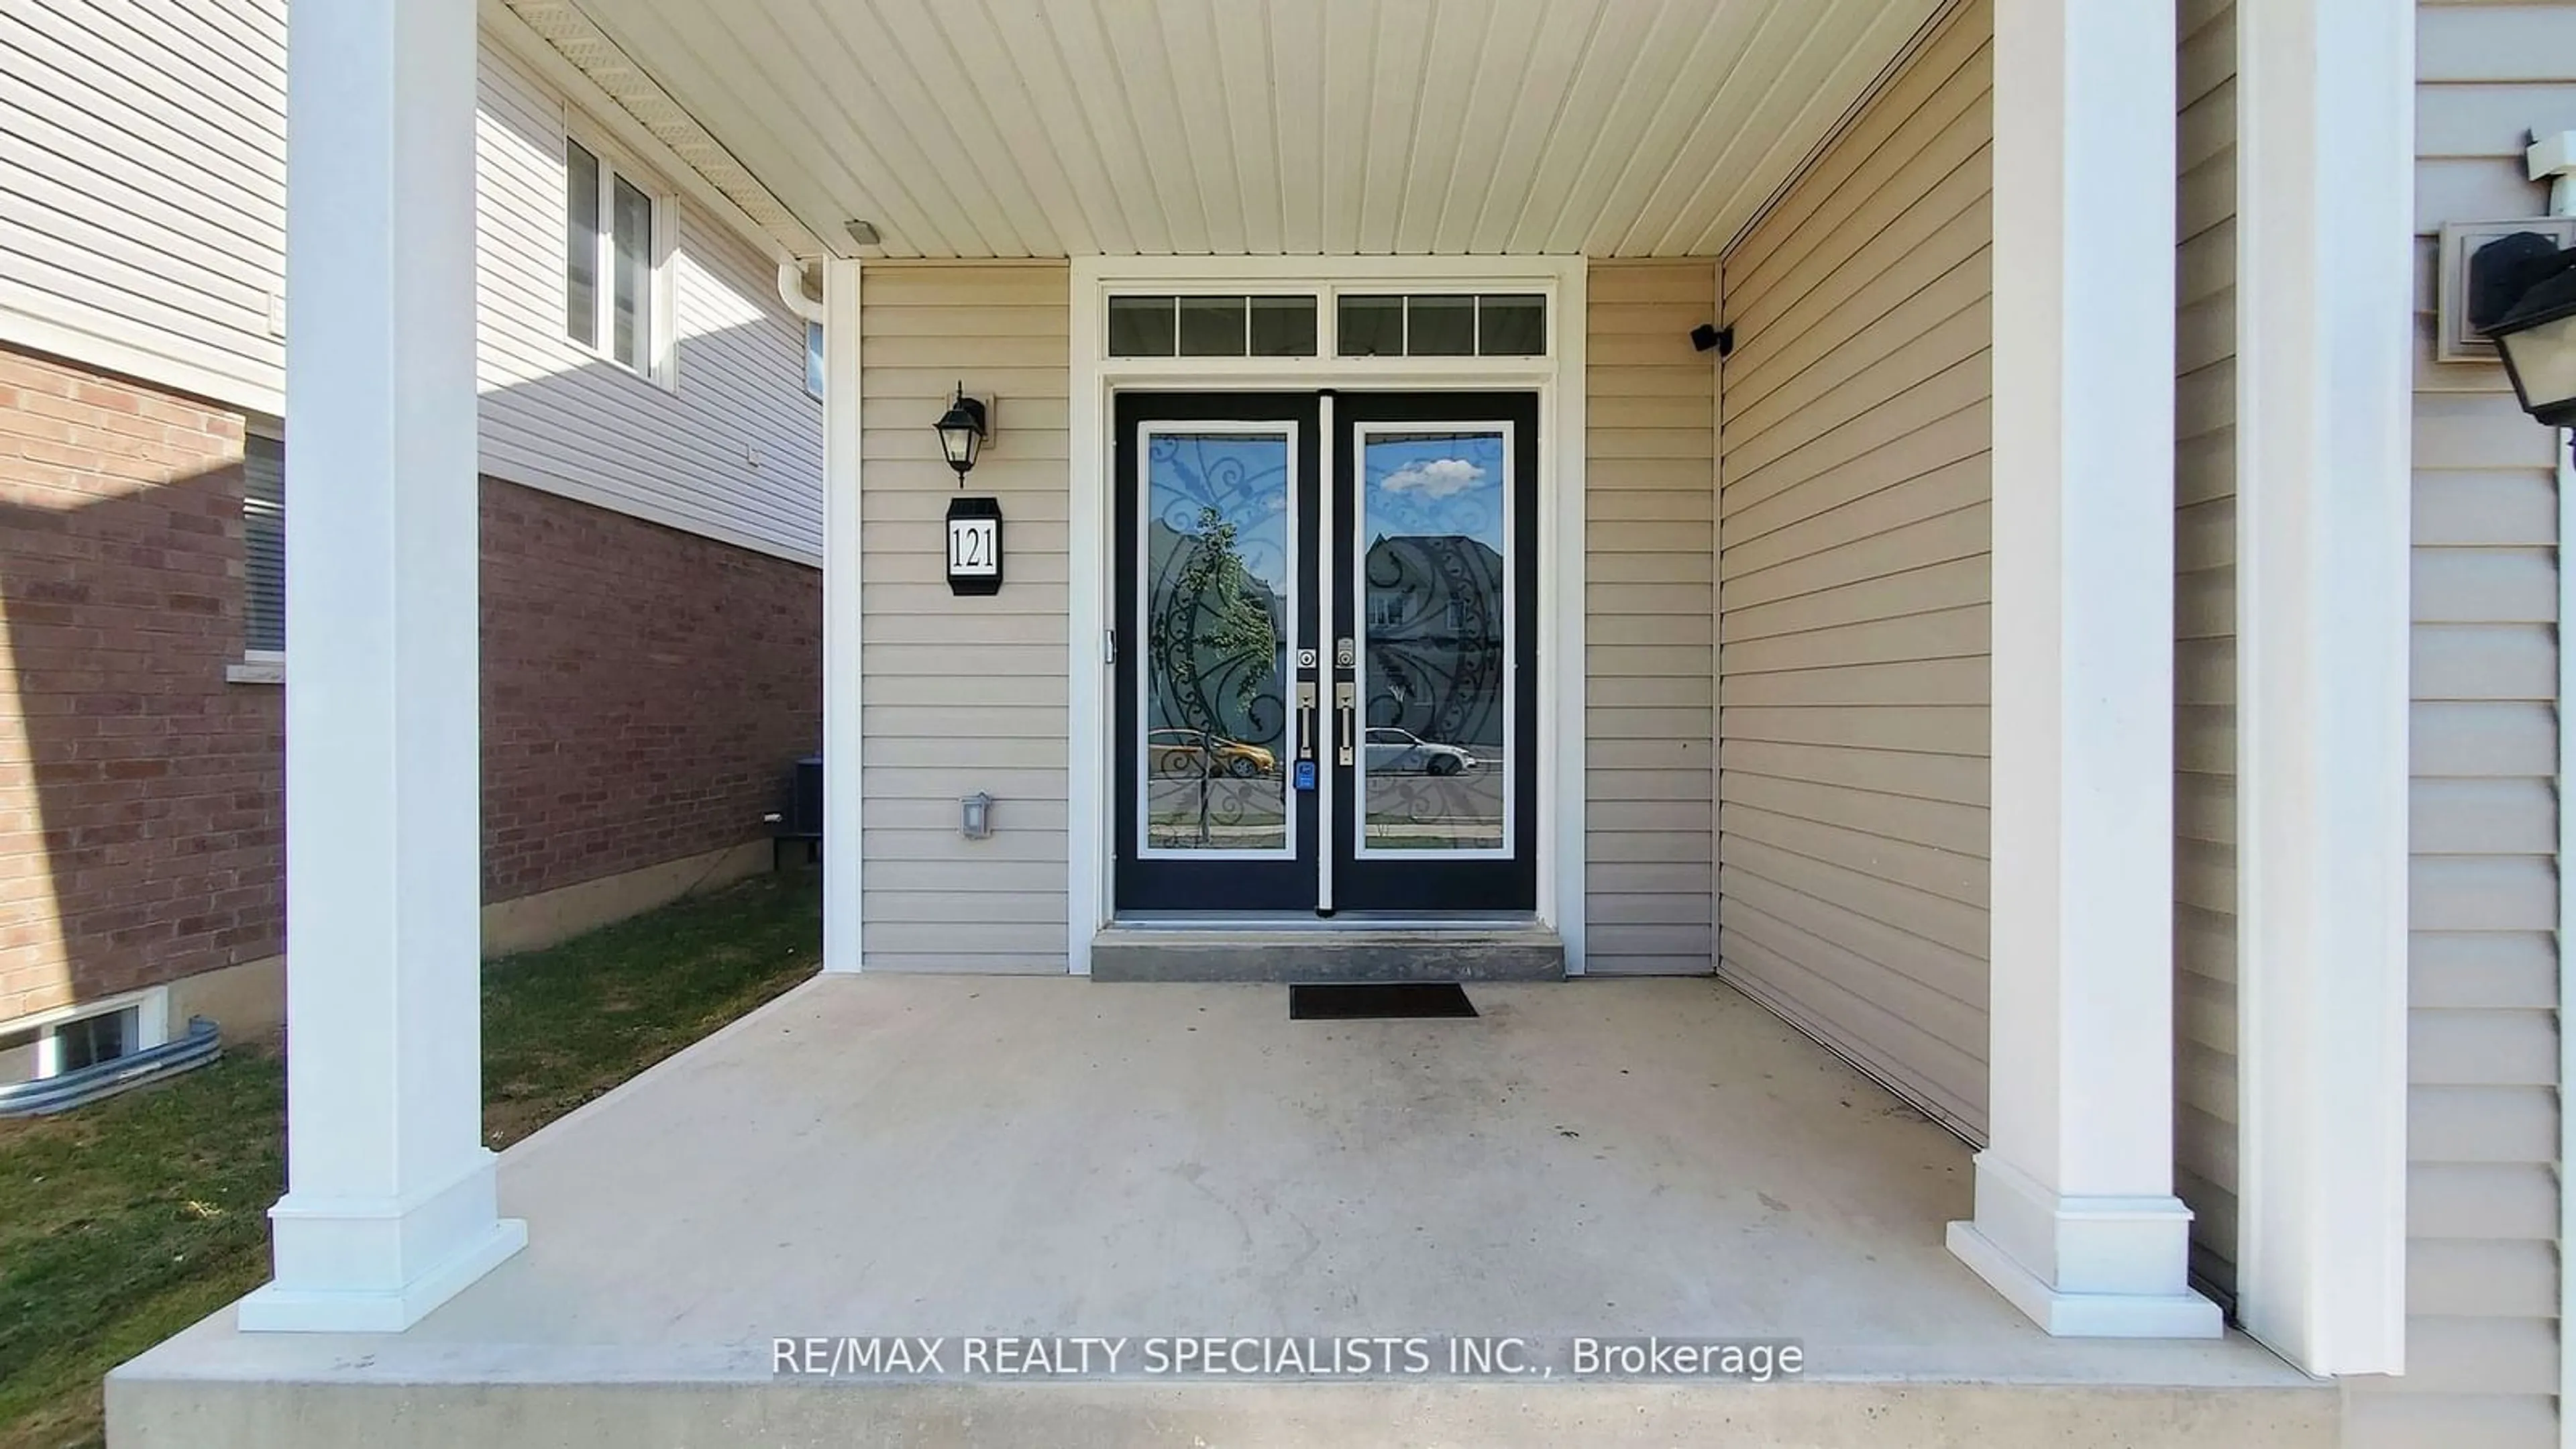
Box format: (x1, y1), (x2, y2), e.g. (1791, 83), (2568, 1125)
(2236, 0), (2416, 1375)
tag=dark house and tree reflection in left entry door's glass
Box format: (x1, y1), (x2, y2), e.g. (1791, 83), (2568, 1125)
(1144, 519), (1288, 750)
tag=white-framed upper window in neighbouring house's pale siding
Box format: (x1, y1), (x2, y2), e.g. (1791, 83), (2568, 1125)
(564, 137), (669, 387)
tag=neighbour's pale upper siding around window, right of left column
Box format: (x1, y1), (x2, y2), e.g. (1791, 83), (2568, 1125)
(476, 41), (822, 562)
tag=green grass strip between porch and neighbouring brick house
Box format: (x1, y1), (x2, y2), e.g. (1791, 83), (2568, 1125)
(0, 874), (822, 1449)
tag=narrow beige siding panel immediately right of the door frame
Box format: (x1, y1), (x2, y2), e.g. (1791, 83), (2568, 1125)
(1585, 258), (1718, 975)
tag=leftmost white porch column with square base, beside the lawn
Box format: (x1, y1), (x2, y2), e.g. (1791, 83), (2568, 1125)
(239, 0), (528, 1330)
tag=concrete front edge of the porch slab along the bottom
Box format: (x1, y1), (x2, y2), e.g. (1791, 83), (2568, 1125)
(108, 1336), (2339, 1449)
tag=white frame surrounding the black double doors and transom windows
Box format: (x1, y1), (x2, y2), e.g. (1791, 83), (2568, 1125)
(1064, 255), (1587, 975)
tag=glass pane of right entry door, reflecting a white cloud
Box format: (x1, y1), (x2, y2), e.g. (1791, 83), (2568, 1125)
(1358, 428), (1512, 856)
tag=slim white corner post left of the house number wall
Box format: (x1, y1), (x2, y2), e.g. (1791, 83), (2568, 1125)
(822, 258), (865, 972)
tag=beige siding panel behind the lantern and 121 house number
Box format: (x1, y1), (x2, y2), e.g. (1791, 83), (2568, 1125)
(858, 263), (1071, 972)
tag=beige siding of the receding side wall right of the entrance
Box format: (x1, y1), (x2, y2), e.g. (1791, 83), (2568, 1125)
(1718, 0), (1994, 1134)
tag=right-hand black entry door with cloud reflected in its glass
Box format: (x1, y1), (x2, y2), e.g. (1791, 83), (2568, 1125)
(1329, 392), (1538, 913)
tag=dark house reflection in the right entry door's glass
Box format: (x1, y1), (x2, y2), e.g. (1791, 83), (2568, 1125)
(1362, 534), (1505, 753)
